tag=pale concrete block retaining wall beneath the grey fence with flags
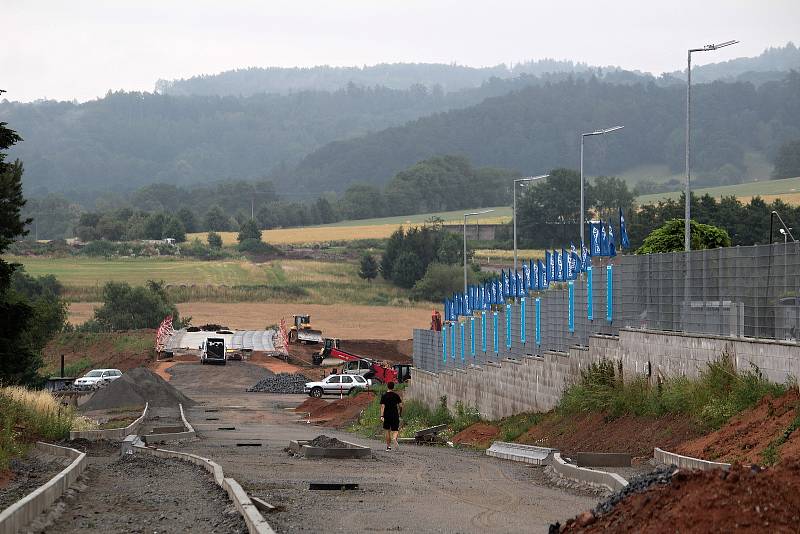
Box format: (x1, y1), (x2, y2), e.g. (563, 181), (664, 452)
(406, 329), (800, 419)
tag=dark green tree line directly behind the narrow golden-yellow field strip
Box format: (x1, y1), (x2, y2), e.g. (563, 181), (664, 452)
(25, 156), (518, 242)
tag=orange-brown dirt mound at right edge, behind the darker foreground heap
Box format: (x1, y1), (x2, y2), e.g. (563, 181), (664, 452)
(676, 388), (800, 464)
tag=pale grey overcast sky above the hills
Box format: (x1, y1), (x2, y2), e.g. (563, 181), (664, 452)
(0, 0), (800, 101)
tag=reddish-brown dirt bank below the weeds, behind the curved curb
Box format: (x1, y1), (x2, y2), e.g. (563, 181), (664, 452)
(517, 413), (701, 457)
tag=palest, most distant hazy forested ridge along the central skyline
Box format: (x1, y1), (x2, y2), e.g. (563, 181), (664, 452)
(156, 59), (589, 96)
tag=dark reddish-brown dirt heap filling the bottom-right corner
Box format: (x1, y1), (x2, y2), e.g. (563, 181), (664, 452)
(562, 462), (800, 534)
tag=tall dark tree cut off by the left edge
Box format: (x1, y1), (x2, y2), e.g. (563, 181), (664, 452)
(0, 108), (42, 384)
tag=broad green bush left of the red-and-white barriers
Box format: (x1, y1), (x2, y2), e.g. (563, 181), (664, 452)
(94, 280), (182, 331)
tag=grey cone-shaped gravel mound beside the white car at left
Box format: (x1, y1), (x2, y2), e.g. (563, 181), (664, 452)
(81, 367), (196, 412)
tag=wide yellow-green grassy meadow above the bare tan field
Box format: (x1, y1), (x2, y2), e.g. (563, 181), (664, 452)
(8, 256), (422, 306)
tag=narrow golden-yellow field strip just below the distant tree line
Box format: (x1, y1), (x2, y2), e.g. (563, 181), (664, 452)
(187, 206), (511, 245)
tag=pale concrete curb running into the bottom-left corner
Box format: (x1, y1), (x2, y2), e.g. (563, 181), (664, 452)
(0, 442), (87, 534)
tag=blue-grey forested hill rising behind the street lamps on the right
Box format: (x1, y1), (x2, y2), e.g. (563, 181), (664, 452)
(290, 72), (800, 194)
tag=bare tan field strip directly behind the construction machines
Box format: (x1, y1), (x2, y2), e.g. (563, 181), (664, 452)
(173, 302), (431, 340)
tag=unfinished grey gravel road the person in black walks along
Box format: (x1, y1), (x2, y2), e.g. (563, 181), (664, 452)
(168, 362), (595, 532)
